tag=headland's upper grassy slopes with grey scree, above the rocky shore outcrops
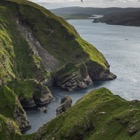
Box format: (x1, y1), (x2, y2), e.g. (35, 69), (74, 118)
(0, 0), (113, 88)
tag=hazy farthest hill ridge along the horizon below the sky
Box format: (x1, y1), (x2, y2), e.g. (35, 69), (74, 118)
(51, 7), (139, 18)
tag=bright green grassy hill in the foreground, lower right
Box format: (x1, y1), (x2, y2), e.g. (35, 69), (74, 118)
(34, 88), (140, 140)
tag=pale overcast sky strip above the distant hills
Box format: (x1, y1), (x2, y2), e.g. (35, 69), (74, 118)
(30, 0), (140, 9)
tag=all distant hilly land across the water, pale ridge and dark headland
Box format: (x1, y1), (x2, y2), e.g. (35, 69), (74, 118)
(51, 7), (140, 26)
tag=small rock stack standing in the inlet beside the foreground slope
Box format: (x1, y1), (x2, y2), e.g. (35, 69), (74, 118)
(56, 96), (72, 115)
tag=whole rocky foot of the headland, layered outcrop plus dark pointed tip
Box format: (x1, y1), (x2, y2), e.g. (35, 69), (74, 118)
(55, 61), (117, 91)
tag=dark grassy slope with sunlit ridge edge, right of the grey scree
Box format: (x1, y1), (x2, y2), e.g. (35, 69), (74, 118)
(7, 0), (107, 68)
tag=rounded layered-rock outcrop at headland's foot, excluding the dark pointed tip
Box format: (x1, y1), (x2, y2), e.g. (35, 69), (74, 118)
(55, 63), (92, 91)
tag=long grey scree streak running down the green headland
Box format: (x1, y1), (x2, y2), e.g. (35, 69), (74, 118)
(16, 19), (59, 71)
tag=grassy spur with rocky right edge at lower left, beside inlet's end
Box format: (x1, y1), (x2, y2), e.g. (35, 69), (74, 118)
(0, 86), (31, 132)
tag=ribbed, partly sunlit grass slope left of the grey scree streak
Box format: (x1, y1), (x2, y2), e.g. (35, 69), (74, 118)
(0, 2), (47, 82)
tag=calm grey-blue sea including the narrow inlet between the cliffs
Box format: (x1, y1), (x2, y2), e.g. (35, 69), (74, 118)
(27, 20), (140, 133)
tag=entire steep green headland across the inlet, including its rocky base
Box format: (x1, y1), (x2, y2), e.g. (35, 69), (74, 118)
(0, 0), (116, 136)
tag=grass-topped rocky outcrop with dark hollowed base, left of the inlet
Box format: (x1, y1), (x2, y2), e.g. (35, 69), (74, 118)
(8, 79), (54, 108)
